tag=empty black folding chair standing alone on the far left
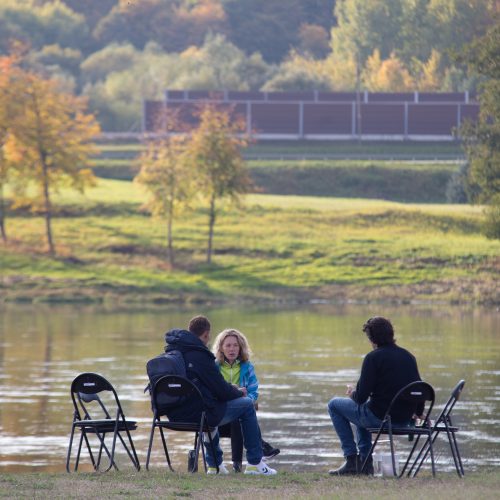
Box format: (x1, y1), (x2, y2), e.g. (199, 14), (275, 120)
(66, 373), (140, 472)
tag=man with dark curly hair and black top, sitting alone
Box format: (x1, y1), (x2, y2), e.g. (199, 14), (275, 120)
(328, 317), (423, 475)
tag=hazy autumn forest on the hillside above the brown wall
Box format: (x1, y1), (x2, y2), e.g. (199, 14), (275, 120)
(0, 0), (498, 131)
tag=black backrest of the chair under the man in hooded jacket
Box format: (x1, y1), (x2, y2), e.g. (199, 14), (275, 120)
(151, 375), (203, 416)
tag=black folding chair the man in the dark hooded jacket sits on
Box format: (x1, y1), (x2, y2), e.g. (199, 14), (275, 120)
(146, 375), (219, 472)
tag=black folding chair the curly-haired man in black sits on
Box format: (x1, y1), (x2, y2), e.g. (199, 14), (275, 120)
(361, 381), (436, 477)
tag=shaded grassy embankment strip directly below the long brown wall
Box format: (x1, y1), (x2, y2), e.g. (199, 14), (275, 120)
(93, 141), (464, 203)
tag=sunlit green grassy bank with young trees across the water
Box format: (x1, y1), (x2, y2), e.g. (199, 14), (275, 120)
(0, 180), (500, 305)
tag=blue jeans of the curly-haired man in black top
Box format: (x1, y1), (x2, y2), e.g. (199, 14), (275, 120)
(328, 398), (382, 457)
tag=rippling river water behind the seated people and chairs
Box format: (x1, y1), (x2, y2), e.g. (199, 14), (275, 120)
(0, 305), (500, 472)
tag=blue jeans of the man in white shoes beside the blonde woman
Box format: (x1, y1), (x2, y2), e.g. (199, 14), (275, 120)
(203, 397), (262, 467)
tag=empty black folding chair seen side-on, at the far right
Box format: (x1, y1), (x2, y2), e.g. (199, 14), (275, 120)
(408, 380), (465, 477)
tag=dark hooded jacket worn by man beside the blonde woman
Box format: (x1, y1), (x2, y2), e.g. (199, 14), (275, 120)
(165, 329), (243, 426)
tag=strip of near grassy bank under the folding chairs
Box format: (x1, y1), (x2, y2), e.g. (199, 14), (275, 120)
(0, 471), (500, 500)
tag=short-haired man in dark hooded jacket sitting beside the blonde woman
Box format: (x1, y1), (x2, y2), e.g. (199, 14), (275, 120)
(165, 316), (276, 475)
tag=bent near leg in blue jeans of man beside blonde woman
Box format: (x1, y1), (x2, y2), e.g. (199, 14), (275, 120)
(220, 397), (262, 465)
